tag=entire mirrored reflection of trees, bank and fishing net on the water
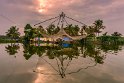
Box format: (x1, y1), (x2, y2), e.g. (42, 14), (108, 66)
(5, 43), (122, 78)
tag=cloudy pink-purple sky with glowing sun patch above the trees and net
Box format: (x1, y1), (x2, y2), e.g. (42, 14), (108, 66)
(0, 0), (124, 35)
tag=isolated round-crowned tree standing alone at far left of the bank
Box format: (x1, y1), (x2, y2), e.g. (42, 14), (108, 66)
(6, 26), (20, 39)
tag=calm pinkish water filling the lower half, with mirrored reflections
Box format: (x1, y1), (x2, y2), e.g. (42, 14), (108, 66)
(0, 44), (124, 83)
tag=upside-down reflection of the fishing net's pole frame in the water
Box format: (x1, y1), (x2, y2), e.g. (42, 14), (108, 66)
(34, 56), (97, 78)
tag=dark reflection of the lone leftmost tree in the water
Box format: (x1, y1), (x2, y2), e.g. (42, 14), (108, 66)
(5, 44), (20, 55)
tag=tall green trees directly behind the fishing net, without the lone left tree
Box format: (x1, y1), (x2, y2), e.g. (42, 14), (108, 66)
(24, 20), (105, 40)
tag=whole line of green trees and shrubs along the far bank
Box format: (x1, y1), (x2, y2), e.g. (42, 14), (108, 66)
(0, 19), (124, 43)
